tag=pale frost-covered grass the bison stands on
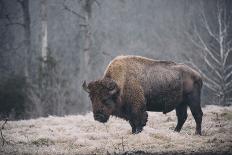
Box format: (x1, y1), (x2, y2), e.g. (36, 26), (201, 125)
(0, 105), (232, 154)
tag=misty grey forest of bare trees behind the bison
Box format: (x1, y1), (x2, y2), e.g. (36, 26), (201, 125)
(0, 0), (232, 119)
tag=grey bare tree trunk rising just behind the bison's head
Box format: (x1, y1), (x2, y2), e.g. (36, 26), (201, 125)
(62, 0), (100, 109)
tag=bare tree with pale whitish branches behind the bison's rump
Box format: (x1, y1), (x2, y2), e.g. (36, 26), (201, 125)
(186, 0), (232, 105)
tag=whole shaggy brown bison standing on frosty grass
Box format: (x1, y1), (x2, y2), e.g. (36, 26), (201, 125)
(83, 56), (203, 134)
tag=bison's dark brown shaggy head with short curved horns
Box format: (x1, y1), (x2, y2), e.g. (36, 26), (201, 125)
(82, 78), (120, 123)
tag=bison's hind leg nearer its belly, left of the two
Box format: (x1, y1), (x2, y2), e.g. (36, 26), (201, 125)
(175, 102), (188, 132)
